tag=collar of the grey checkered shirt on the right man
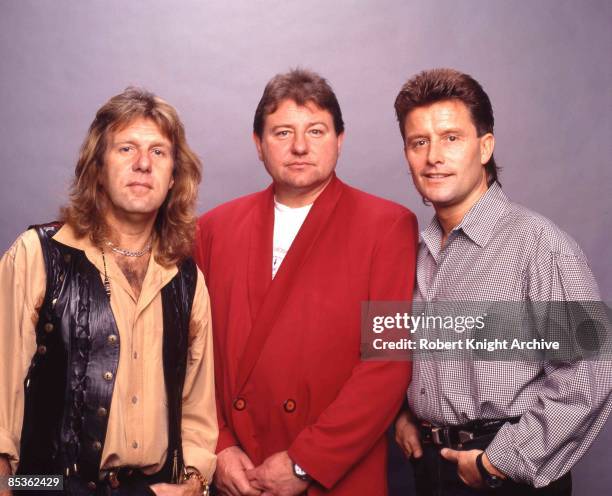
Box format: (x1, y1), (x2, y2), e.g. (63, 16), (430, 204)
(421, 182), (510, 258)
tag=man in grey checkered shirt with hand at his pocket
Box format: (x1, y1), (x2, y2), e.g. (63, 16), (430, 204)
(395, 69), (612, 495)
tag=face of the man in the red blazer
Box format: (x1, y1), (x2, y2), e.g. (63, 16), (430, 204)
(253, 100), (344, 206)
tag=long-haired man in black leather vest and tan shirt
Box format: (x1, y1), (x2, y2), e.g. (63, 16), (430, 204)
(0, 88), (218, 495)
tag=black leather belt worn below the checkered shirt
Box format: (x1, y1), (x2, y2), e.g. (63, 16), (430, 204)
(420, 417), (520, 448)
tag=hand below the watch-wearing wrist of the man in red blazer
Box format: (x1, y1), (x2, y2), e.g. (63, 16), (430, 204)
(247, 451), (309, 496)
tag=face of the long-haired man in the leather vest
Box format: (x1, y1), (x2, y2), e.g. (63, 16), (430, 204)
(99, 118), (174, 224)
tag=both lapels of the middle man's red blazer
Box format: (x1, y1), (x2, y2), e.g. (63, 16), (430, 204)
(236, 175), (344, 393)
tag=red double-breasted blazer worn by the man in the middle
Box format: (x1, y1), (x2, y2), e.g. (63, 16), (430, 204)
(195, 177), (418, 496)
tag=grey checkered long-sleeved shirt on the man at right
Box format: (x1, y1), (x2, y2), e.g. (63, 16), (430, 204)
(408, 183), (612, 487)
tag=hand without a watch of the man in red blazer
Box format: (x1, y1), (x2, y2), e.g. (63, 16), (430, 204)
(215, 446), (261, 496)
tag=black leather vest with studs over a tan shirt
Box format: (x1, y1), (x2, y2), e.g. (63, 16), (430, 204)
(18, 223), (197, 482)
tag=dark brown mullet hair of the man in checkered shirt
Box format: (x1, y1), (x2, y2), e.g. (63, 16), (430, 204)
(395, 69), (499, 185)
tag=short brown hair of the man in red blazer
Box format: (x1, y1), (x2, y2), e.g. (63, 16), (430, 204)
(253, 69), (344, 138)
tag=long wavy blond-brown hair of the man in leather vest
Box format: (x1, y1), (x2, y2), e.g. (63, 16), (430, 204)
(60, 87), (201, 266)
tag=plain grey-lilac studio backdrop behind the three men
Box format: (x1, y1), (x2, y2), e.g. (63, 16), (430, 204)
(0, 0), (612, 494)
